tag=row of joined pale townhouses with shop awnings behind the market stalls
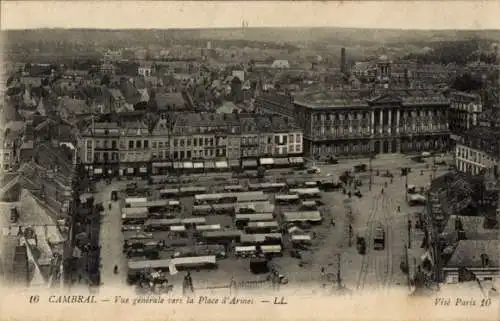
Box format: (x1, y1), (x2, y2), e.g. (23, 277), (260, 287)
(78, 113), (303, 177)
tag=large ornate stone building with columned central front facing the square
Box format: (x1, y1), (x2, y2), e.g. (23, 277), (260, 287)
(258, 88), (450, 159)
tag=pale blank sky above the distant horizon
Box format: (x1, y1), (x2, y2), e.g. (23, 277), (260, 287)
(0, 0), (500, 29)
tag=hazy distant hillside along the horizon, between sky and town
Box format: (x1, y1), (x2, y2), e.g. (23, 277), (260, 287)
(2, 28), (500, 47)
